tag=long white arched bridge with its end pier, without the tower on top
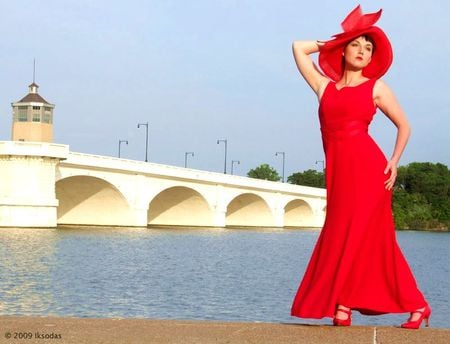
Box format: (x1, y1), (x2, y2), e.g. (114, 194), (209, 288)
(0, 141), (326, 228)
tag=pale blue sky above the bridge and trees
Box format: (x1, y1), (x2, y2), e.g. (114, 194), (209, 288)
(0, 0), (450, 178)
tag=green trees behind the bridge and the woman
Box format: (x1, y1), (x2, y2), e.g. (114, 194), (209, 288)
(247, 162), (450, 231)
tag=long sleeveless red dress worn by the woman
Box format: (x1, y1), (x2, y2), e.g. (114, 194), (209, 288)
(291, 79), (426, 319)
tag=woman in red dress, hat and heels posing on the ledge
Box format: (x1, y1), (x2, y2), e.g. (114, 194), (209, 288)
(291, 6), (431, 329)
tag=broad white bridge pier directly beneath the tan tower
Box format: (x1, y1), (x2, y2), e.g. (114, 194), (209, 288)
(0, 141), (69, 227)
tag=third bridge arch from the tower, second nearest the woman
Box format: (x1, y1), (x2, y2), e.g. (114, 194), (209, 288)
(225, 193), (275, 227)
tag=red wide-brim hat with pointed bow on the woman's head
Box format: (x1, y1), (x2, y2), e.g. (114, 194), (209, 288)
(319, 5), (393, 81)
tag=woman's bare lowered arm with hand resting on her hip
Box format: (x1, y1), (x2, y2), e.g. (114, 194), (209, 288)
(373, 80), (411, 190)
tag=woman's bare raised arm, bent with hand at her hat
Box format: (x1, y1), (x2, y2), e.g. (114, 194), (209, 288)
(292, 41), (329, 99)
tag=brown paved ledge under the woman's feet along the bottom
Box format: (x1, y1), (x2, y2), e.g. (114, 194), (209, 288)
(0, 317), (450, 344)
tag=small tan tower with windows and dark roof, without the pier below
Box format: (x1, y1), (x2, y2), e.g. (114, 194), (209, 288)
(11, 81), (55, 142)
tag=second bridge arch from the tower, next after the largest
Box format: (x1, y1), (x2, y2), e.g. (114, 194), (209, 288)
(147, 186), (213, 227)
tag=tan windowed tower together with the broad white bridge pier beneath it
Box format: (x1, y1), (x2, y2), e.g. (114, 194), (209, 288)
(0, 78), (69, 227)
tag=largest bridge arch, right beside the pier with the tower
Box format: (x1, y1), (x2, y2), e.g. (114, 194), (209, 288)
(55, 175), (134, 226)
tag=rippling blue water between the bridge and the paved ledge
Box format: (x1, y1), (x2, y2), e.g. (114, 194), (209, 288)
(0, 228), (450, 328)
